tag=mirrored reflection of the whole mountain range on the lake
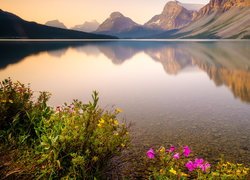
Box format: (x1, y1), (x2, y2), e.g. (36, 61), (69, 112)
(0, 42), (250, 103)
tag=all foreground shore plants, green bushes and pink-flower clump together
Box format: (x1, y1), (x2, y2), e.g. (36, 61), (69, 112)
(0, 79), (249, 179)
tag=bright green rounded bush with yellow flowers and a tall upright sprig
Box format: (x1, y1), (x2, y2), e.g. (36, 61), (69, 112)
(38, 92), (129, 178)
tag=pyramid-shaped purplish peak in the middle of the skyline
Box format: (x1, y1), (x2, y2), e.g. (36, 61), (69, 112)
(96, 12), (140, 34)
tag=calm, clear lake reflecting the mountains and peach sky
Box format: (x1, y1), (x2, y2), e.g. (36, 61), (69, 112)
(0, 41), (250, 169)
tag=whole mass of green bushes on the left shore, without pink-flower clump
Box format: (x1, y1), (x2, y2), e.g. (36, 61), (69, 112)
(0, 79), (130, 179)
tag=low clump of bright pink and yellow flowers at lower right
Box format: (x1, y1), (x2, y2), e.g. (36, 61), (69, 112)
(147, 146), (249, 180)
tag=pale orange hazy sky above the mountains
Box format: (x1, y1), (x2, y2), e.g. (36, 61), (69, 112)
(0, 0), (209, 27)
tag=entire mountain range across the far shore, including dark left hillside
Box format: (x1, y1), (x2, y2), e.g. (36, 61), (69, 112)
(0, 0), (250, 39)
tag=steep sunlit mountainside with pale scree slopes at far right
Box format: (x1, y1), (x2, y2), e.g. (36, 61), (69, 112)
(153, 0), (250, 39)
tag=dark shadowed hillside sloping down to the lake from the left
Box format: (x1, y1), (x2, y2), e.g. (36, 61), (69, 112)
(0, 10), (115, 39)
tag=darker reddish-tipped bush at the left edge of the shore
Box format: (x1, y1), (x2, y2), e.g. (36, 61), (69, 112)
(0, 79), (52, 146)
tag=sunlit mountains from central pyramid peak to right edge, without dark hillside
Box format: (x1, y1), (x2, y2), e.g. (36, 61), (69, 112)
(96, 0), (250, 39)
